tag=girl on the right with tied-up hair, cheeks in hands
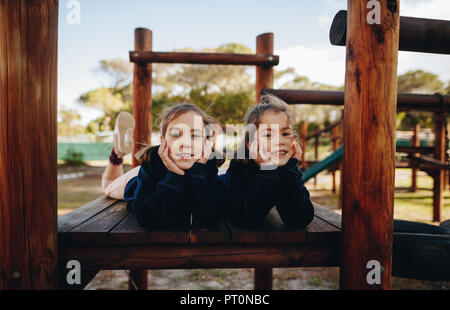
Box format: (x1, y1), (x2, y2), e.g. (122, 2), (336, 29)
(221, 95), (314, 228)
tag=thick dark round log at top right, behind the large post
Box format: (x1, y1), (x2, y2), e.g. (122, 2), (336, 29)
(330, 10), (450, 54)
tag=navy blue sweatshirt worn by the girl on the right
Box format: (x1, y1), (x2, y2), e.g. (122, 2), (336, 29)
(221, 158), (314, 228)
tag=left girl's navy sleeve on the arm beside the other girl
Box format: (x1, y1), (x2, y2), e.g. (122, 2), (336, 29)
(186, 162), (227, 227)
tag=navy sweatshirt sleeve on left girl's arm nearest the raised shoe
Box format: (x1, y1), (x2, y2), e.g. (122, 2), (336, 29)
(131, 167), (190, 229)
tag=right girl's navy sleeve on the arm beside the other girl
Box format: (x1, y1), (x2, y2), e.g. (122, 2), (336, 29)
(226, 161), (280, 226)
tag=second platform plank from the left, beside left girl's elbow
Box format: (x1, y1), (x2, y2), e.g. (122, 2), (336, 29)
(66, 201), (129, 244)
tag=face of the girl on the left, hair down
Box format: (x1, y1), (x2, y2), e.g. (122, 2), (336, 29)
(161, 111), (206, 170)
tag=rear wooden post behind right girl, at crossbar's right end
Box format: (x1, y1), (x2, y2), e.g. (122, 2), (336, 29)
(255, 32), (273, 290)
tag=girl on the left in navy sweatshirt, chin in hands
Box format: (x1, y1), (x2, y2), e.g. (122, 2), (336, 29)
(124, 104), (227, 229)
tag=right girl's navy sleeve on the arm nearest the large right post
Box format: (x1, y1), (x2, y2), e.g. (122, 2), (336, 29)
(277, 158), (314, 228)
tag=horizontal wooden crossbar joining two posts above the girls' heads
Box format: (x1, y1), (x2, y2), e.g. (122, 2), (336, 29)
(130, 49), (280, 67)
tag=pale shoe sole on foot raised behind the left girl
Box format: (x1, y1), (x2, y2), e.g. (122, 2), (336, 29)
(114, 112), (136, 157)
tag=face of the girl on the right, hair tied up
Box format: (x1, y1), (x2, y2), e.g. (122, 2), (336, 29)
(257, 111), (295, 166)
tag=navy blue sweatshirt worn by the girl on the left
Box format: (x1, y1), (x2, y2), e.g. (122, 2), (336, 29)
(124, 147), (227, 229)
